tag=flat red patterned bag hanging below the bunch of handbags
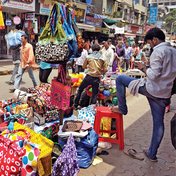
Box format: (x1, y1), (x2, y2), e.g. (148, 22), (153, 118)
(51, 66), (71, 111)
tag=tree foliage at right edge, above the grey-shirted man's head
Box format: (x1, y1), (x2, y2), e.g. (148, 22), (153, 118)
(164, 9), (176, 33)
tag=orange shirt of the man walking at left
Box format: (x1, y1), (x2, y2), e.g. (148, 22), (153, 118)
(21, 43), (38, 68)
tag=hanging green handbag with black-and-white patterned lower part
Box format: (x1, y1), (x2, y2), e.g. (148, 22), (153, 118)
(35, 3), (69, 63)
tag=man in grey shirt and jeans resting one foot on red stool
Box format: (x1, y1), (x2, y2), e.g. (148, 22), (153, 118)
(112, 28), (176, 162)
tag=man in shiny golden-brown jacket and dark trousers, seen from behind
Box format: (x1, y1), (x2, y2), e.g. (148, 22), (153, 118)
(74, 44), (107, 109)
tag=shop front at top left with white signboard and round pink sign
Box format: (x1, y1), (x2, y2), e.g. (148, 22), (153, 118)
(0, 0), (35, 59)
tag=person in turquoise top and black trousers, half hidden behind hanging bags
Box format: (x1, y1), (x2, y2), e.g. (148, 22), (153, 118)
(39, 61), (52, 83)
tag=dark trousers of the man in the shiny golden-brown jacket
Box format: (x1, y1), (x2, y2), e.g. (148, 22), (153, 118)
(75, 75), (100, 107)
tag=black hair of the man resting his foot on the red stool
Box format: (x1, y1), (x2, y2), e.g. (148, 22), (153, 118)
(144, 27), (166, 42)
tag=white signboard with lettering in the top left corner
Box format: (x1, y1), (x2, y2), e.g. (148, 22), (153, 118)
(3, 0), (35, 12)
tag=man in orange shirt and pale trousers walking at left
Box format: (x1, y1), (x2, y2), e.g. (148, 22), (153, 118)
(10, 35), (38, 92)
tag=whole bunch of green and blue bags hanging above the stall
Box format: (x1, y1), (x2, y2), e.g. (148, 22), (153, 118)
(36, 3), (84, 63)
